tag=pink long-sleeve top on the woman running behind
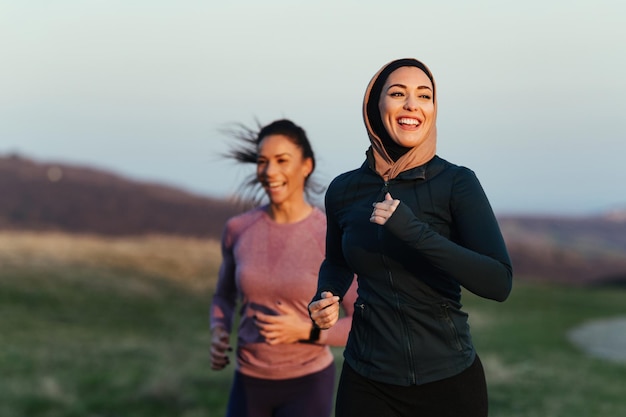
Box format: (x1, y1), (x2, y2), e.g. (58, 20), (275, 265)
(211, 207), (356, 379)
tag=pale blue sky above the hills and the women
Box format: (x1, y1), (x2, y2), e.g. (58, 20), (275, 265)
(0, 0), (626, 216)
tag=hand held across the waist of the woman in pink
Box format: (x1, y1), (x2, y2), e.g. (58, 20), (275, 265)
(255, 301), (311, 345)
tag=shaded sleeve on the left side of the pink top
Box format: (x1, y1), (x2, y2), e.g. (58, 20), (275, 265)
(210, 223), (237, 333)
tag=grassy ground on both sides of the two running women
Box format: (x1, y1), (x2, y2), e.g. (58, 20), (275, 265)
(0, 233), (626, 417)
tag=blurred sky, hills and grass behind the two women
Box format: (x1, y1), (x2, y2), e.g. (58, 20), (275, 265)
(0, 0), (626, 417)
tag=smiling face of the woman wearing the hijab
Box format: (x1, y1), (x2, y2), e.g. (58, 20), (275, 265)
(378, 67), (435, 148)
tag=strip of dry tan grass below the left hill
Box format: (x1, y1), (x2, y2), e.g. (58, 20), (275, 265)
(0, 231), (221, 289)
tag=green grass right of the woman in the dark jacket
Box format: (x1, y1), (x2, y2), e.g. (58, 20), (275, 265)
(465, 284), (626, 417)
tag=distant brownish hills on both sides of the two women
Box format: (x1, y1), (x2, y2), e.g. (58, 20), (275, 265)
(0, 155), (626, 285)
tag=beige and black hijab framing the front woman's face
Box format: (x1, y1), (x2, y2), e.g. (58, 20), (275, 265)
(363, 58), (437, 181)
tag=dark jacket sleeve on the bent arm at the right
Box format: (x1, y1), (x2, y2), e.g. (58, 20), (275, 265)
(385, 169), (513, 301)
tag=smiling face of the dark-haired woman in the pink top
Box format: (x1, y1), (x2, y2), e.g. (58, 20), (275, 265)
(256, 134), (313, 205)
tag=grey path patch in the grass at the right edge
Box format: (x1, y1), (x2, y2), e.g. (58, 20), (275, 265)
(568, 317), (626, 363)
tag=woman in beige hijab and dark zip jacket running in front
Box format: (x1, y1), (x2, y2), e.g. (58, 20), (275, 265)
(309, 59), (512, 417)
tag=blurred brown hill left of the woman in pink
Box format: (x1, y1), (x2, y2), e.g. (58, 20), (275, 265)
(0, 155), (241, 238)
